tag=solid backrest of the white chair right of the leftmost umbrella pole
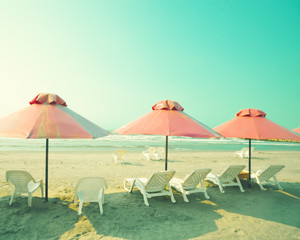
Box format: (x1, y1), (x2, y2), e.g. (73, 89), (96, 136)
(75, 177), (107, 202)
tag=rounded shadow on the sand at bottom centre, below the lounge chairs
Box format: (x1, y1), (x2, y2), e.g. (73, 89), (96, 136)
(83, 191), (221, 239)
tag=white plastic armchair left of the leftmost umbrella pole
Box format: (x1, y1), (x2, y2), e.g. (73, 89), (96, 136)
(6, 170), (44, 207)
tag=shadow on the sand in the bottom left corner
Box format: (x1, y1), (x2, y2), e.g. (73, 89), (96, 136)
(0, 196), (78, 240)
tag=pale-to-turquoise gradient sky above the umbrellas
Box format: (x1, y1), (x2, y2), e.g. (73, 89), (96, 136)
(0, 0), (300, 130)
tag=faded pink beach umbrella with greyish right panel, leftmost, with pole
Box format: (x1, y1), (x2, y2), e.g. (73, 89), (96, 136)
(0, 93), (109, 201)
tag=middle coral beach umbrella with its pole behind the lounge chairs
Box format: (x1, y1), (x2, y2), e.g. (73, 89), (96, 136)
(114, 100), (220, 170)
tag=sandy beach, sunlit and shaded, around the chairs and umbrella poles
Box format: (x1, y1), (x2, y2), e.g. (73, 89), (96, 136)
(0, 151), (300, 239)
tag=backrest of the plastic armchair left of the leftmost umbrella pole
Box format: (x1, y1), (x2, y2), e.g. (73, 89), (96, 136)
(6, 170), (35, 193)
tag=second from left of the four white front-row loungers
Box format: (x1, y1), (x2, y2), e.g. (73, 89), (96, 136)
(170, 168), (211, 202)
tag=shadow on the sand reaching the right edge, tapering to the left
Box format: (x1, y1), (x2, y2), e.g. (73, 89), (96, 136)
(223, 182), (300, 228)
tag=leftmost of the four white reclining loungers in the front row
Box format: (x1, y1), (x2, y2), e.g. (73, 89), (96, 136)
(124, 171), (176, 206)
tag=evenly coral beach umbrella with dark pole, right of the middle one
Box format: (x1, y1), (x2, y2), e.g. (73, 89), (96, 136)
(214, 108), (300, 186)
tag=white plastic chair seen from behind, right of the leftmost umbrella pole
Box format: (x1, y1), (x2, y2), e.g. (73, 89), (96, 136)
(74, 177), (107, 215)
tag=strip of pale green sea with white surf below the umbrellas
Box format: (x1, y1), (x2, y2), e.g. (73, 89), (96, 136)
(0, 134), (300, 151)
